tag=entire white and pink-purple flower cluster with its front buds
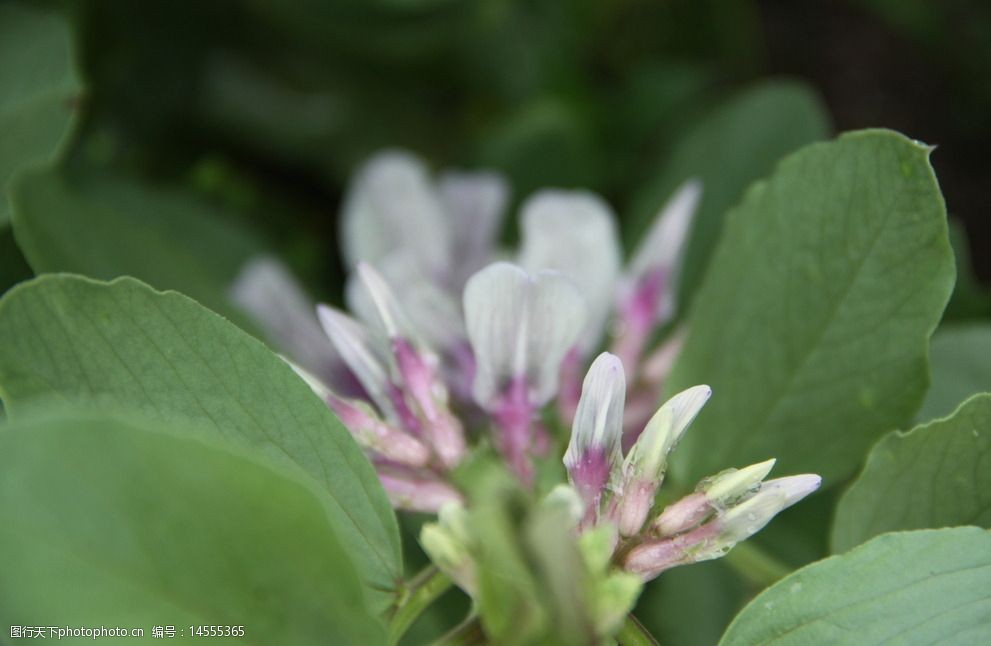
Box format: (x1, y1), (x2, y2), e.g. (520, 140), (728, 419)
(234, 153), (819, 592)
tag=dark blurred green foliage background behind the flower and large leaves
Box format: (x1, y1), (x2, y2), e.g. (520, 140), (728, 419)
(0, 0), (991, 644)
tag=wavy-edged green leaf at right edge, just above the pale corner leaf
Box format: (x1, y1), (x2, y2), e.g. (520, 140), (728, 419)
(833, 394), (991, 552)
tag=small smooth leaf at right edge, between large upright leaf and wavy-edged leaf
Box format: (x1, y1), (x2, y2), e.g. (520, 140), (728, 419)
(918, 324), (991, 421)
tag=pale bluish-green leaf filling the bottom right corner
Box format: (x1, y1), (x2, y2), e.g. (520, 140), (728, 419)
(719, 527), (991, 646)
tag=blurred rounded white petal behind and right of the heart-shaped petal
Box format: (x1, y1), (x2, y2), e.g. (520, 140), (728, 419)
(520, 191), (622, 350)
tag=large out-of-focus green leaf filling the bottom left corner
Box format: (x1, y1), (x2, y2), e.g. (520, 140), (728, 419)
(0, 415), (385, 644)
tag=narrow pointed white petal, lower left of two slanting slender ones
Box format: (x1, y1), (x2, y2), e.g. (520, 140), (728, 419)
(317, 305), (395, 418)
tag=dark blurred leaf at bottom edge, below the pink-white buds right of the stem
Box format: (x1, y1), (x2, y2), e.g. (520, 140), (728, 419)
(633, 561), (747, 646)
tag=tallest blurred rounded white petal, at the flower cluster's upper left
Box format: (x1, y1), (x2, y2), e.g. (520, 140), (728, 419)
(341, 151), (451, 276)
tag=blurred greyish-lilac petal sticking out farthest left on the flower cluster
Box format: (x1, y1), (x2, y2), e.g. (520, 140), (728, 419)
(231, 256), (343, 385)
